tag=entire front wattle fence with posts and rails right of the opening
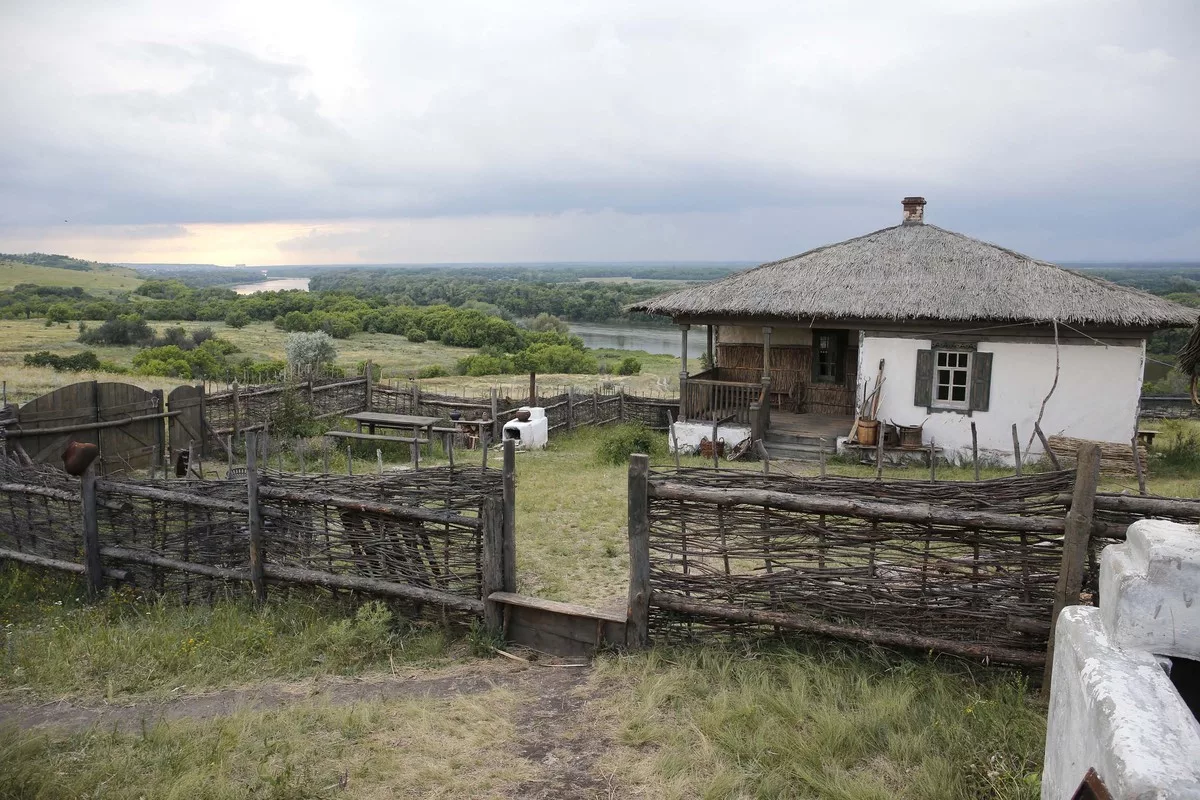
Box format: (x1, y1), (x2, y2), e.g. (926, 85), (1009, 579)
(628, 447), (1200, 681)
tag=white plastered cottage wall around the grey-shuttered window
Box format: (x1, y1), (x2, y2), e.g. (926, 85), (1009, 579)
(858, 333), (1145, 464)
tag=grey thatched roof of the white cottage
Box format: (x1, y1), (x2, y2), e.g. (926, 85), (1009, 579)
(629, 223), (1198, 327)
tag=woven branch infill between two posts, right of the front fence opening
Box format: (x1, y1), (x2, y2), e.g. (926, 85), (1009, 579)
(649, 470), (1072, 664)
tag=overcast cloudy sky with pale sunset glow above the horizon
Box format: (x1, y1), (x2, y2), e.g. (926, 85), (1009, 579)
(0, 0), (1200, 264)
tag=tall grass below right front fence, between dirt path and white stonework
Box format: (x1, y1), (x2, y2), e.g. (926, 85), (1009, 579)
(601, 645), (1045, 800)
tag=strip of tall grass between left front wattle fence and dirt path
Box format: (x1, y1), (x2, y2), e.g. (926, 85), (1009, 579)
(0, 565), (452, 699)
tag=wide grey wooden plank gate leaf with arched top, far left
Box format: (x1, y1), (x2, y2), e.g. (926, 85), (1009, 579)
(6, 380), (163, 475)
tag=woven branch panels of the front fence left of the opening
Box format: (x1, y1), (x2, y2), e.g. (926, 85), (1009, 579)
(0, 461), (503, 613)
